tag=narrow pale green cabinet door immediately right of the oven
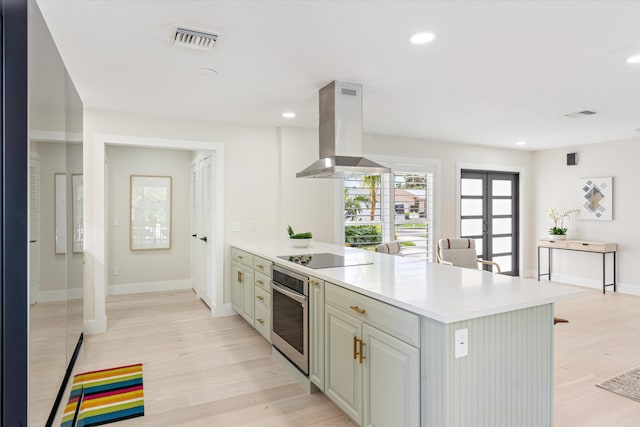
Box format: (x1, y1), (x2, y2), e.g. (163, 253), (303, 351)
(309, 277), (324, 391)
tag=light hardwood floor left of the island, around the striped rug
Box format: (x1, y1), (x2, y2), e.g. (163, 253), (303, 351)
(52, 290), (353, 427)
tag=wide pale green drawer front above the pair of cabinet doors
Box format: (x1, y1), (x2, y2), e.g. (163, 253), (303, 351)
(324, 282), (420, 347)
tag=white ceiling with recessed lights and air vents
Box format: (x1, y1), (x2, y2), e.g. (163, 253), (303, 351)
(38, 0), (640, 150)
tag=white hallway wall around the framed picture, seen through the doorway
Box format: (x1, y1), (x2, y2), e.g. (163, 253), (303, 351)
(106, 145), (192, 292)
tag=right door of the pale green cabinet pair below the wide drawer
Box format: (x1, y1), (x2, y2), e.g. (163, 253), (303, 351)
(362, 324), (420, 427)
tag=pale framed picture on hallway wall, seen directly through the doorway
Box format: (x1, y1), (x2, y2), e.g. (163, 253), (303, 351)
(130, 175), (172, 251)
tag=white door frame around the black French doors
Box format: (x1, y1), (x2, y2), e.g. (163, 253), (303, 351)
(455, 162), (528, 277)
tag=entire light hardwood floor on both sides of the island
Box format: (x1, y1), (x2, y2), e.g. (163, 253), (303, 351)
(33, 285), (640, 427)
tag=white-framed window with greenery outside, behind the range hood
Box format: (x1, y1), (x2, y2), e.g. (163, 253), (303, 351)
(344, 162), (434, 260)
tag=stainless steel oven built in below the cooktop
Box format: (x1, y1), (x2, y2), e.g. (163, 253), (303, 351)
(271, 264), (309, 375)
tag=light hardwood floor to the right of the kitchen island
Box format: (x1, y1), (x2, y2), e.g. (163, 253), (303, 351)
(551, 285), (640, 427)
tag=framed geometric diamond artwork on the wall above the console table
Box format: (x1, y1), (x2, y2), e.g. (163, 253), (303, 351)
(578, 176), (613, 221)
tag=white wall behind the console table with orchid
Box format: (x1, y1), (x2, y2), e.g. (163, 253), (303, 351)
(531, 138), (640, 294)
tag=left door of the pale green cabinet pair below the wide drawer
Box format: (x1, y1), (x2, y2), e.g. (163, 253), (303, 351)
(325, 306), (362, 425)
